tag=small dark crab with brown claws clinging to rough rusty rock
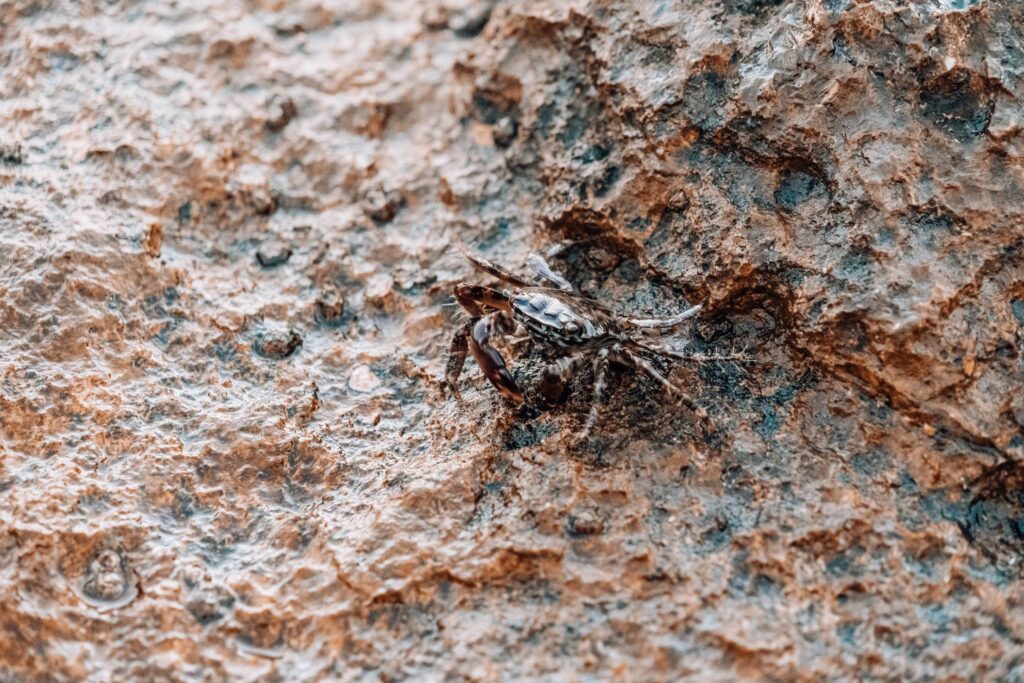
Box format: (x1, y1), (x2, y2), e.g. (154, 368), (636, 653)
(445, 244), (707, 441)
